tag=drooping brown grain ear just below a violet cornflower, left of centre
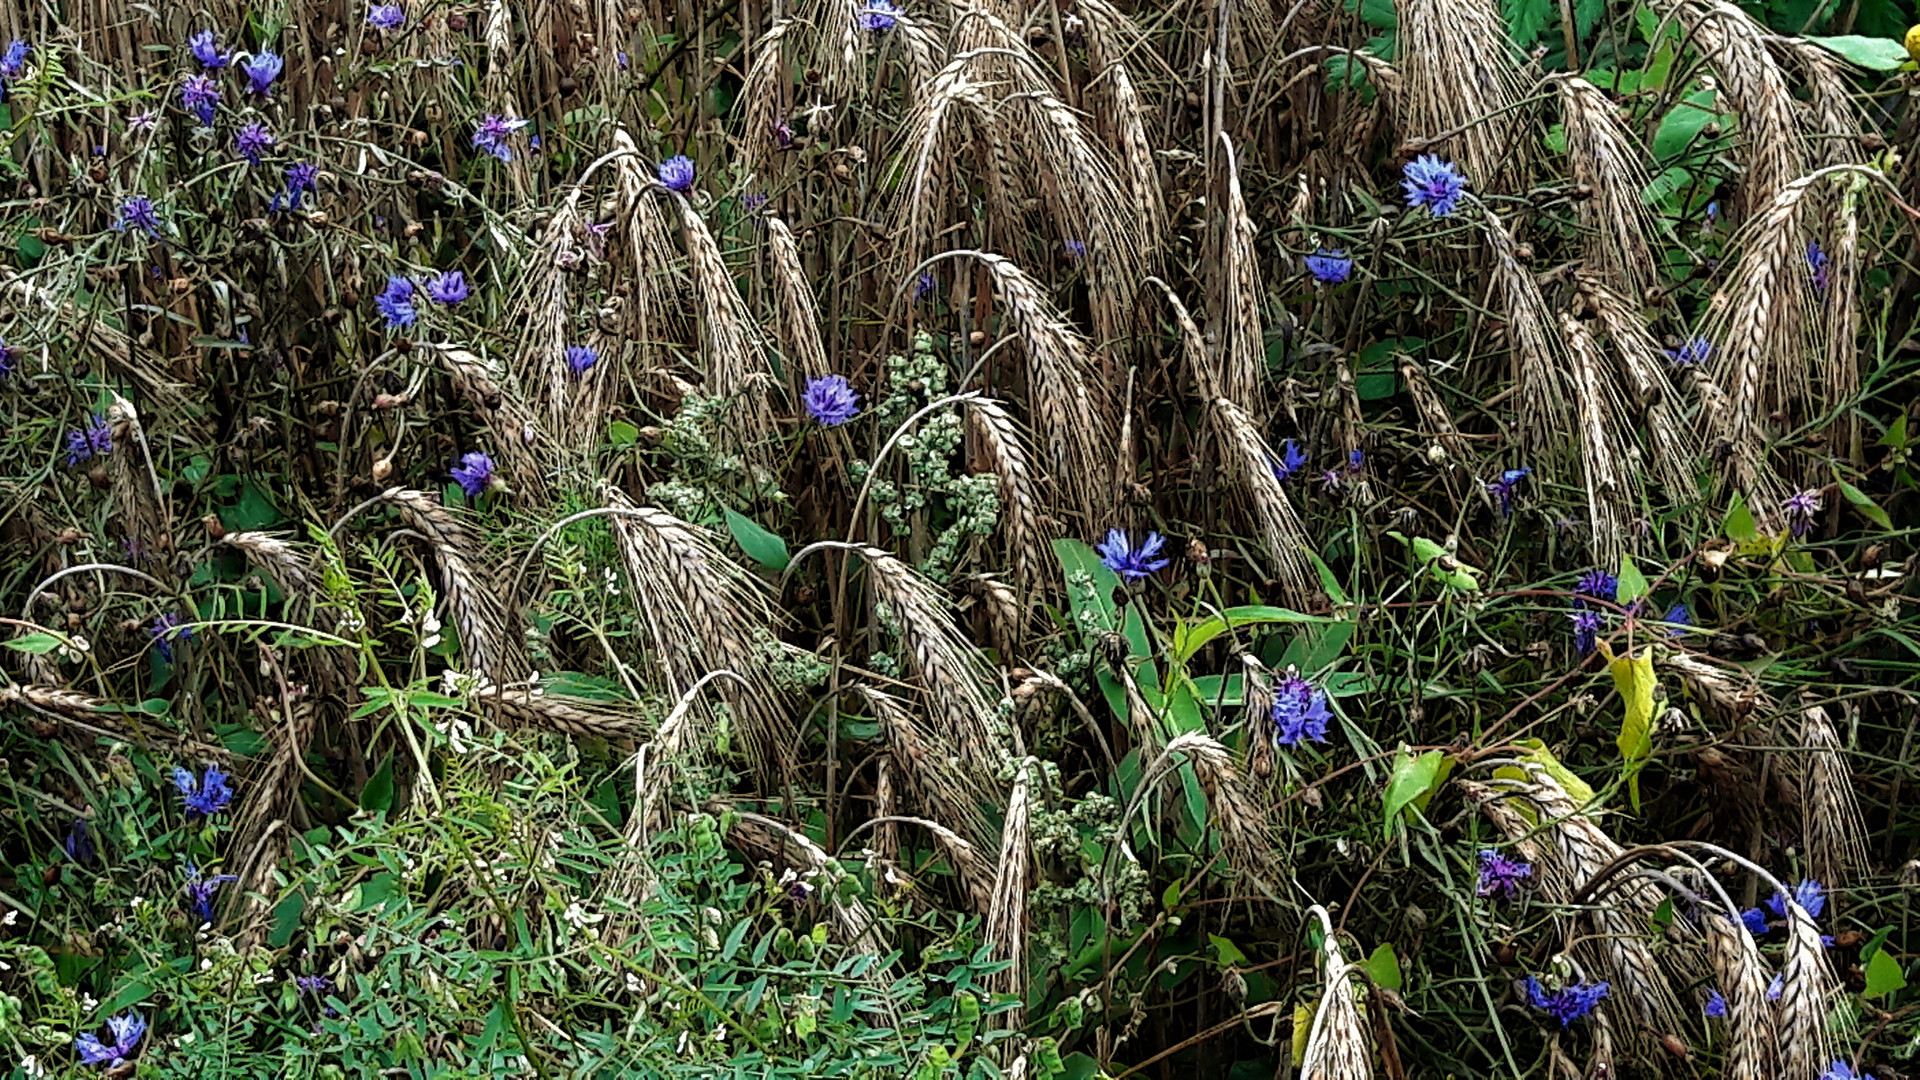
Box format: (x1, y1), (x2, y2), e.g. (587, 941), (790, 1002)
(380, 488), (532, 684)
